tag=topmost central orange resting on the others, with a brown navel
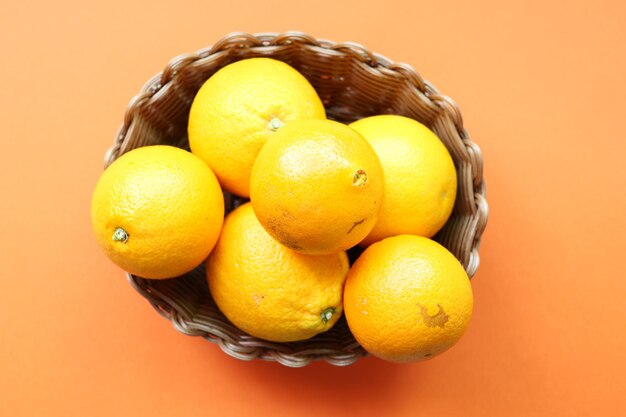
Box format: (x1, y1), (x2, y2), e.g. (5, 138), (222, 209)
(250, 120), (384, 254)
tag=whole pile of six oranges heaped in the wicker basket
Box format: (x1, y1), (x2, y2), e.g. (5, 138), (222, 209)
(92, 58), (472, 362)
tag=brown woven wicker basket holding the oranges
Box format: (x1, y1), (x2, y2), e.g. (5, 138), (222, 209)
(105, 32), (487, 367)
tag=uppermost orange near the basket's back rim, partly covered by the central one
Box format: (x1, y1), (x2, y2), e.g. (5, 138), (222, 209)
(188, 58), (326, 197)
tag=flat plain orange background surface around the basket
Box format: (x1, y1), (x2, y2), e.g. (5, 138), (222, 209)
(0, 0), (626, 417)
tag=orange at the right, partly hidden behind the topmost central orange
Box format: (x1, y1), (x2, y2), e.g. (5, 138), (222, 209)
(350, 115), (457, 246)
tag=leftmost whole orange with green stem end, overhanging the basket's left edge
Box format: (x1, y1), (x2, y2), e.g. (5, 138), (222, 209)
(91, 145), (224, 279)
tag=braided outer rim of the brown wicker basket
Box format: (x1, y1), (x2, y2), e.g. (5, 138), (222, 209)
(104, 31), (488, 367)
